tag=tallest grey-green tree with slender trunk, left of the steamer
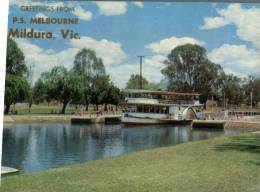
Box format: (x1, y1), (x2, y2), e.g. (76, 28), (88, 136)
(73, 48), (106, 110)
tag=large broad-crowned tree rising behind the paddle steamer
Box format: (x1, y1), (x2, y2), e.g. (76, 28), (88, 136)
(162, 44), (223, 102)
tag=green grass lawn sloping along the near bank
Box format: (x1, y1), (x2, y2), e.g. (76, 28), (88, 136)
(0, 134), (260, 192)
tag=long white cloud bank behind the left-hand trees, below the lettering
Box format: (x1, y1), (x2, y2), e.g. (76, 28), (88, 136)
(16, 37), (126, 85)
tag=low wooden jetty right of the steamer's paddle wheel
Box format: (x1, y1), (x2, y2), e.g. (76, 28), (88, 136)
(191, 120), (226, 129)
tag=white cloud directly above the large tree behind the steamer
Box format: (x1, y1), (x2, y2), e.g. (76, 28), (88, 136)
(146, 37), (205, 54)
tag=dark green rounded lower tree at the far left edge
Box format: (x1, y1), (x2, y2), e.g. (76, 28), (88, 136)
(4, 74), (30, 114)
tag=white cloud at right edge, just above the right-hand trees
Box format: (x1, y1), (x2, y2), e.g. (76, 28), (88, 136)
(208, 44), (260, 76)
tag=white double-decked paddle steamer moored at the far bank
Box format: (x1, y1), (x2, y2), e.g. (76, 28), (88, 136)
(121, 89), (203, 125)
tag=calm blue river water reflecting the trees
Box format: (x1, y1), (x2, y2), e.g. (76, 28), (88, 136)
(3, 122), (245, 172)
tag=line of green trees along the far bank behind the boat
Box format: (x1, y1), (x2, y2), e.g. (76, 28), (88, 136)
(5, 38), (260, 114)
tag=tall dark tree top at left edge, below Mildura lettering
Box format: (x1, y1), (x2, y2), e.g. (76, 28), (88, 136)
(6, 38), (27, 77)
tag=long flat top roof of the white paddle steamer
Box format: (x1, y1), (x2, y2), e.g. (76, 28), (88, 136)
(125, 89), (200, 96)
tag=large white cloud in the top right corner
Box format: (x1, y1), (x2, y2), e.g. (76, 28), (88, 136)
(200, 4), (260, 49)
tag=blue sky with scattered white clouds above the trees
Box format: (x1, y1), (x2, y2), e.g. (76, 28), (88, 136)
(9, 0), (260, 88)
